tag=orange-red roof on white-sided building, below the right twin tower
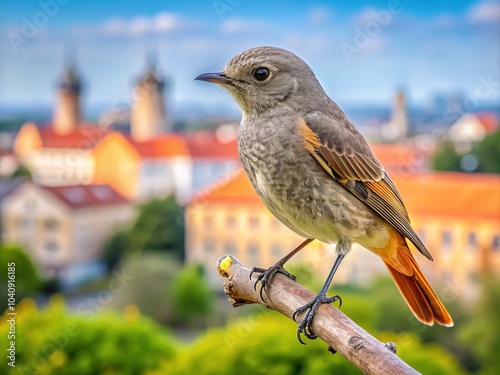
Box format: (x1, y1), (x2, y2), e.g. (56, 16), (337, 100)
(126, 134), (189, 158)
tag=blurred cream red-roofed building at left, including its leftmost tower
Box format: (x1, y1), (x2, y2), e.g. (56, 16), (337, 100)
(13, 65), (109, 186)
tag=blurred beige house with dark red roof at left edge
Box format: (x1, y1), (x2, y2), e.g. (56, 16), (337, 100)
(2, 181), (135, 284)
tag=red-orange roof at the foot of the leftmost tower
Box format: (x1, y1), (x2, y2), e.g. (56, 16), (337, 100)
(38, 124), (109, 149)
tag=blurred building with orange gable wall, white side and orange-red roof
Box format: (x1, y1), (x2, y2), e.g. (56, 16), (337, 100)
(93, 132), (192, 203)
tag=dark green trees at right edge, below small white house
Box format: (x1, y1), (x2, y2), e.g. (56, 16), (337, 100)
(433, 131), (500, 174)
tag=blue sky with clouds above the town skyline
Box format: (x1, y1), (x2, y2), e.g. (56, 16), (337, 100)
(0, 0), (500, 116)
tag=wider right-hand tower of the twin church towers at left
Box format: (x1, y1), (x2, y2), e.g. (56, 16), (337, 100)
(130, 58), (170, 141)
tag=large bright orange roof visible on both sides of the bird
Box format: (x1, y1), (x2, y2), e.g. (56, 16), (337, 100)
(191, 170), (500, 220)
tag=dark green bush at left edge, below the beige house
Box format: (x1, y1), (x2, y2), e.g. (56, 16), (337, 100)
(0, 244), (41, 312)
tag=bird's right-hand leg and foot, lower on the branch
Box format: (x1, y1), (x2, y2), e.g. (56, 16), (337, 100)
(293, 253), (345, 345)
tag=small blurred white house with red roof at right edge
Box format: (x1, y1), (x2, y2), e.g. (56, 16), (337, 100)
(448, 113), (499, 153)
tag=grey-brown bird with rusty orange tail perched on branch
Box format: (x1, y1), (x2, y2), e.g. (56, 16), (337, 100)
(195, 46), (453, 343)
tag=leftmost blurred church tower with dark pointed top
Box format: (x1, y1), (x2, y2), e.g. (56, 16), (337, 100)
(52, 64), (82, 134)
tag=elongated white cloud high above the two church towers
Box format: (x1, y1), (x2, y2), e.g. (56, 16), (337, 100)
(102, 12), (182, 35)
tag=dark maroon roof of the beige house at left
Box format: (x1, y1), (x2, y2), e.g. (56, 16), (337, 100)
(42, 184), (128, 208)
